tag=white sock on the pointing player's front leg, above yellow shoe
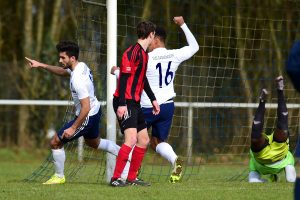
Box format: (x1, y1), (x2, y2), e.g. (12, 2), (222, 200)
(52, 148), (66, 178)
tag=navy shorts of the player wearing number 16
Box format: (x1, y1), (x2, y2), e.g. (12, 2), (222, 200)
(142, 102), (175, 142)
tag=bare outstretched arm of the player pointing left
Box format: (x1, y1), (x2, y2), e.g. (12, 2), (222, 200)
(25, 57), (70, 76)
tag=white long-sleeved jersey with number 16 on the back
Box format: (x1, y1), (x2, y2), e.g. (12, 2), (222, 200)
(141, 24), (199, 108)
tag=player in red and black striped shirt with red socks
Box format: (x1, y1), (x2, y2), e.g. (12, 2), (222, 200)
(110, 22), (159, 187)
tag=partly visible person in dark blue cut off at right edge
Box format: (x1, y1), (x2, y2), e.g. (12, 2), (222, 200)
(286, 41), (300, 200)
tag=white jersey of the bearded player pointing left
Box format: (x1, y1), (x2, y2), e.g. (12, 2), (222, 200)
(68, 62), (100, 116)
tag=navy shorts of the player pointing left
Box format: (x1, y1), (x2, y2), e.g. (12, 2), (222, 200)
(57, 108), (101, 143)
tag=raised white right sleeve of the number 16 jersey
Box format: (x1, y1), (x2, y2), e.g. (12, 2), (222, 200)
(176, 23), (199, 61)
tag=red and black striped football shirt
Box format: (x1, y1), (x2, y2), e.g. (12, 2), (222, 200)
(114, 43), (148, 104)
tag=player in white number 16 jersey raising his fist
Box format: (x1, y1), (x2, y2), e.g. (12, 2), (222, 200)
(111, 16), (199, 183)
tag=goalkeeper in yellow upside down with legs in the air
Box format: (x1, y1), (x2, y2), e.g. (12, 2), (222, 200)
(249, 76), (296, 183)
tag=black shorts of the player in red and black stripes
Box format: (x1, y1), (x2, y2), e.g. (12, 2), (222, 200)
(113, 97), (147, 134)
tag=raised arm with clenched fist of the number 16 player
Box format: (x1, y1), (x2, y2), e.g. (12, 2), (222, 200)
(173, 16), (199, 60)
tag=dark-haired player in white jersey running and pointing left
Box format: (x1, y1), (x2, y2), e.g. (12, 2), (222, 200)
(26, 41), (120, 184)
